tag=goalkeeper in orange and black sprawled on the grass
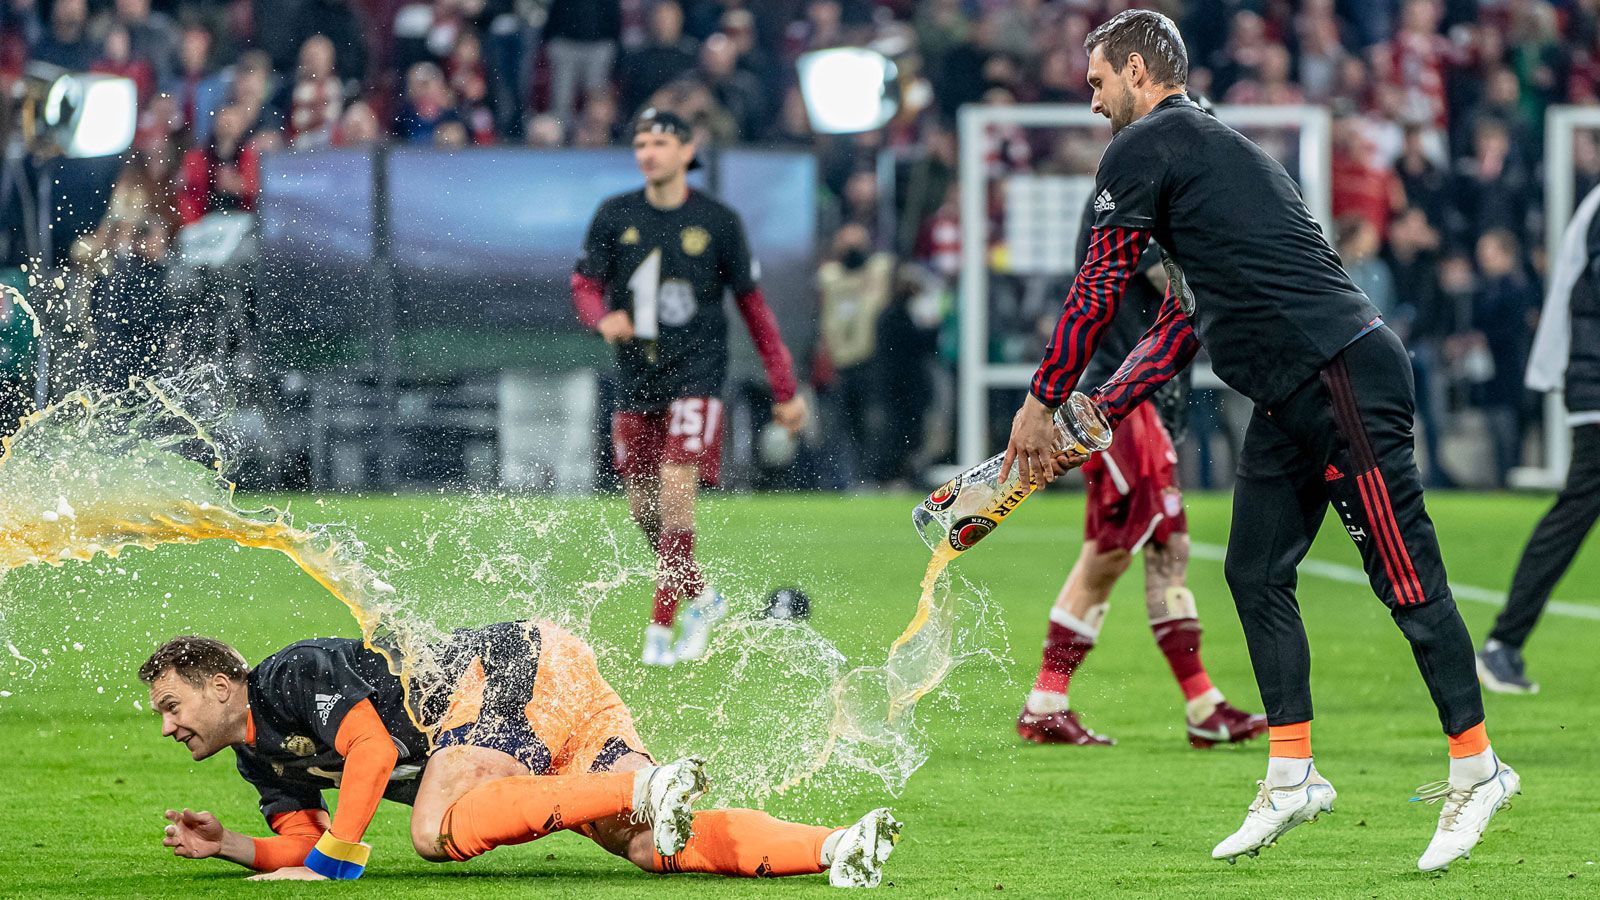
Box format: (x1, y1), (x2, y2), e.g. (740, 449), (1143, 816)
(139, 621), (899, 887)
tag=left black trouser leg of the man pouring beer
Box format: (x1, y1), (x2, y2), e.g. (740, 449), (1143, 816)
(1224, 412), (1326, 725)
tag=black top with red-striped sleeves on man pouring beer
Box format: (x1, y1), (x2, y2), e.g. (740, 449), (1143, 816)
(1032, 94), (1379, 412)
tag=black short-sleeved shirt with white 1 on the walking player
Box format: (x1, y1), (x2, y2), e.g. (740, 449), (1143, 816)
(578, 189), (757, 412)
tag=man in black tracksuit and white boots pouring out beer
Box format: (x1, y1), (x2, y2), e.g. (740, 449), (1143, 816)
(1006, 11), (1520, 871)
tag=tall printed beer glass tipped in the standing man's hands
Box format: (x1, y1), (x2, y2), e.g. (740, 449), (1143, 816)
(910, 392), (1110, 556)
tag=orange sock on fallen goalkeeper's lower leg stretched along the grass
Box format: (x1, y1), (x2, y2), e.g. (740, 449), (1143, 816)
(656, 809), (838, 878)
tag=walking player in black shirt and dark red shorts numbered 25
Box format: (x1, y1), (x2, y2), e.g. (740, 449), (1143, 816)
(573, 109), (806, 666)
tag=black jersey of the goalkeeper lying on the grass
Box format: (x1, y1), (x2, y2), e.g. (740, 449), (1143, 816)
(234, 637), (429, 822)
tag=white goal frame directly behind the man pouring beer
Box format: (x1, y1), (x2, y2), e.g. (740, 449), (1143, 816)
(957, 104), (1333, 469)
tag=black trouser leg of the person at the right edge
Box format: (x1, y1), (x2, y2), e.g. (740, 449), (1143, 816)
(1490, 423), (1600, 647)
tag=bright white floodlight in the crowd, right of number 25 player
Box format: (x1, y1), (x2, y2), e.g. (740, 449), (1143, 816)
(797, 46), (899, 135)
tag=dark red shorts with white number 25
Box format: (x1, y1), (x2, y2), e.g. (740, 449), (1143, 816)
(611, 397), (722, 485)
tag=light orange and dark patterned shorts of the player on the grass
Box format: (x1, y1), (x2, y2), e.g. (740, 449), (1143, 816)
(434, 621), (648, 775)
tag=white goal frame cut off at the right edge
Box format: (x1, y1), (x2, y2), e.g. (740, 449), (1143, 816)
(1510, 106), (1600, 488)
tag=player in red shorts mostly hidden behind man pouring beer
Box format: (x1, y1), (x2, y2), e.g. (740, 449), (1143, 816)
(1016, 180), (1267, 749)
